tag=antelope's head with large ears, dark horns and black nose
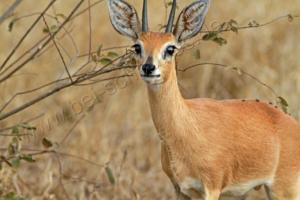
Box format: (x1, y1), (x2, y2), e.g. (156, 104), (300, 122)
(108, 0), (209, 85)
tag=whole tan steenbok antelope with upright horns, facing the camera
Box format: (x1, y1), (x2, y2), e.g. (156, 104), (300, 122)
(108, 0), (300, 200)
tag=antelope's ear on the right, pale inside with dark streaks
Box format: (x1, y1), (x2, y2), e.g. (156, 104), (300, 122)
(174, 0), (209, 43)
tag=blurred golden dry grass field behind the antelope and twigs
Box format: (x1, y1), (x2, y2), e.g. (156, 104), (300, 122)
(0, 0), (300, 200)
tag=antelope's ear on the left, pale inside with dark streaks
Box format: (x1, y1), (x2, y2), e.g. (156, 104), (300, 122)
(108, 0), (141, 40)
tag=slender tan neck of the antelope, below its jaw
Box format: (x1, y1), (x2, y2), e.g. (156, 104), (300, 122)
(148, 64), (191, 140)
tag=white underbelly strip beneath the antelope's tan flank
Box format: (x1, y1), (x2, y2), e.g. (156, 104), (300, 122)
(222, 179), (272, 196)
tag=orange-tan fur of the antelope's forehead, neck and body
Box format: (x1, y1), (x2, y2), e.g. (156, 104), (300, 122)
(140, 32), (300, 200)
